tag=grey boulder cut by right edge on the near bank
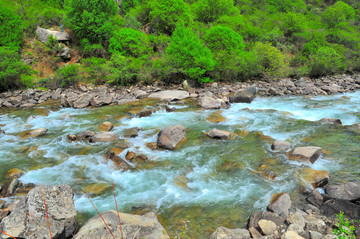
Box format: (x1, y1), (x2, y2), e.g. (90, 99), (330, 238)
(325, 182), (360, 201)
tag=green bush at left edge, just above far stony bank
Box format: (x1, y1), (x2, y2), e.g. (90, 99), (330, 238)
(0, 47), (34, 92)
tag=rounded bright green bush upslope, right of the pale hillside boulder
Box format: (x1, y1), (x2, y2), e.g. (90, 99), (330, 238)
(109, 28), (150, 57)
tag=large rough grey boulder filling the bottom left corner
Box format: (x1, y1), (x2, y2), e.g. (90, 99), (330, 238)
(0, 185), (76, 239)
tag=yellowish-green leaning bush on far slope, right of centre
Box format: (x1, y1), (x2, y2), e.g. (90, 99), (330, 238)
(253, 42), (287, 77)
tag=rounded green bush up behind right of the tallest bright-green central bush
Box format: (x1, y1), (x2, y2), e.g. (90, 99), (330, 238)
(204, 26), (245, 54)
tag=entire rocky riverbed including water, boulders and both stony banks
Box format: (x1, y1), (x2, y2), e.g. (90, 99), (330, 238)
(0, 76), (360, 238)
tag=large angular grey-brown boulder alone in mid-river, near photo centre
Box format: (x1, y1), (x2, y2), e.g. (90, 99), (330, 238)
(157, 124), (186, 149)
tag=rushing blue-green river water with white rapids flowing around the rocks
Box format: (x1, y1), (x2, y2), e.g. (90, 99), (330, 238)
(0, 92), (360, 238)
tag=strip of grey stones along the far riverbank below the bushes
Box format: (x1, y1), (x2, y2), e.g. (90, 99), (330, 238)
(0, 74), (360, 108)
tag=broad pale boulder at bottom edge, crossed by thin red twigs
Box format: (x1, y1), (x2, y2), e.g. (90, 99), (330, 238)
(74, 210), (170, 239)
